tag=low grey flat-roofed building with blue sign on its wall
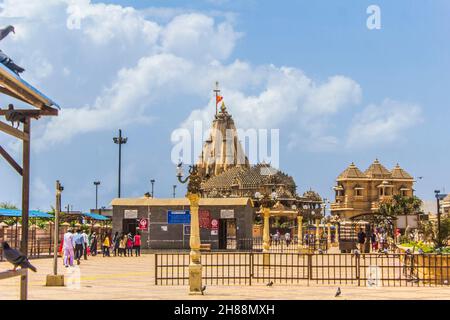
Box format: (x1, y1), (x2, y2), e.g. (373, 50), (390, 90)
(111, 197), (254, 249)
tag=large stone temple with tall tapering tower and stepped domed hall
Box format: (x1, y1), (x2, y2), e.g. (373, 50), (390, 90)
(197, 89), (322, 211)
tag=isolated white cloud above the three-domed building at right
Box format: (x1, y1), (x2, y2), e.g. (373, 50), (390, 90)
(347, 99), (423, 148)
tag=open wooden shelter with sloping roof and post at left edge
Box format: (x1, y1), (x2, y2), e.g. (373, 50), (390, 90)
(0, 64), (59, 254)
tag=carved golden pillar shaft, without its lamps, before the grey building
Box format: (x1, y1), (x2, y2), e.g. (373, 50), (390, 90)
(187, 193), (202, 295)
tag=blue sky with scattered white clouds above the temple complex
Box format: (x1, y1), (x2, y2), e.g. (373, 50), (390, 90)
(0, 0), (450, 211)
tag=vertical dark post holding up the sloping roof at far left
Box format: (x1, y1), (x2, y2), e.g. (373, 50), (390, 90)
(20, 118), (31, 256)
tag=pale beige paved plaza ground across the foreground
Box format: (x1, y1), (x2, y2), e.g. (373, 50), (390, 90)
(0, 254), (450, 300)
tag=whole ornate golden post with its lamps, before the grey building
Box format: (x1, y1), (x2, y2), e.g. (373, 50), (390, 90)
(177, 162), (203, 295)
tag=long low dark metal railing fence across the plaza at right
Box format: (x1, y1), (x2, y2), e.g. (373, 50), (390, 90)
(155, 252), (450, 287)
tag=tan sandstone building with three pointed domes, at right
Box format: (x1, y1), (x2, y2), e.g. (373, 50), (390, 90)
(331, 159), (415, 219)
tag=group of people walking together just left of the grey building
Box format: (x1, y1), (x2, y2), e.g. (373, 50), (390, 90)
(59, 229), (141, 268)
